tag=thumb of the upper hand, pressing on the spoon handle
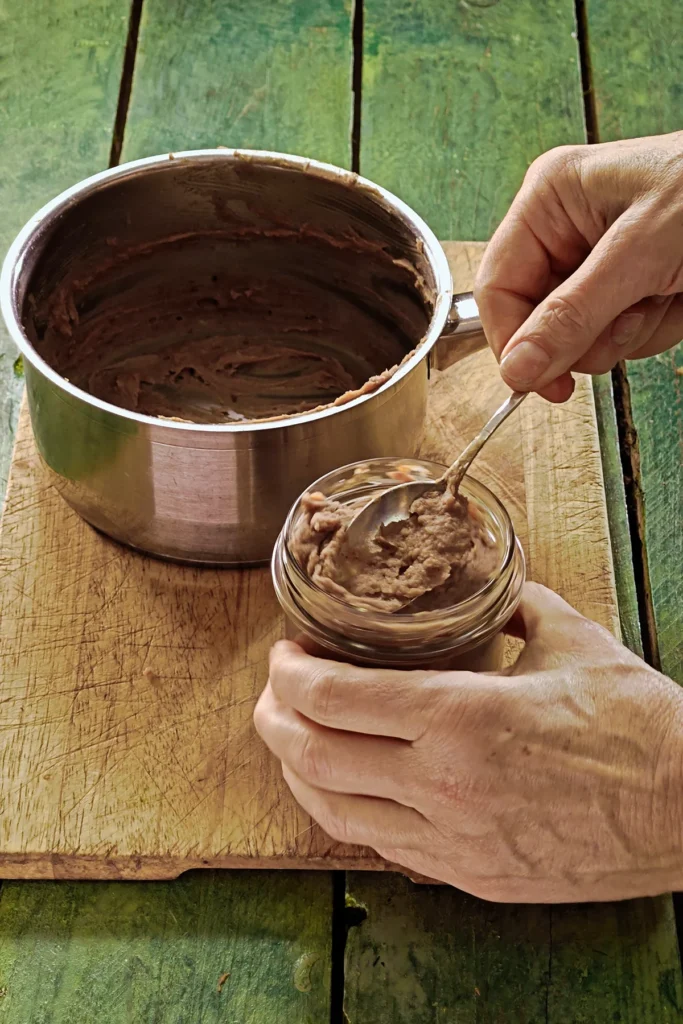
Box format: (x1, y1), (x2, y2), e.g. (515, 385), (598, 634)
(501, 219), (649, 391)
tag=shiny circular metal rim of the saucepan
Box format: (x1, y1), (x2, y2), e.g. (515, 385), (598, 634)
(0, 147), (453, 434)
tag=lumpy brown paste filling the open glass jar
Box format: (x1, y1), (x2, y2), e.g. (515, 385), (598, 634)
(290, 492), (500, 612)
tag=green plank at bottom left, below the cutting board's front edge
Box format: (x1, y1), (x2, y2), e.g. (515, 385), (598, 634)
(0, 871), (332, 1024)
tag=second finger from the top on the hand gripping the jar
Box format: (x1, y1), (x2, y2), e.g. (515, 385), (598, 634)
(254, 686), (422, 806)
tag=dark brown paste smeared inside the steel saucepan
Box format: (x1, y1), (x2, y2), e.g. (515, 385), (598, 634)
(34, 226), (430, 423)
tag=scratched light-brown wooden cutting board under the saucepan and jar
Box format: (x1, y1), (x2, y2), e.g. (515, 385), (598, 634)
(0, 243), (618, 879)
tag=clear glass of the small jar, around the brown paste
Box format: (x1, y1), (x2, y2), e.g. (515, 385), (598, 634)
(272, 459), (525, 672)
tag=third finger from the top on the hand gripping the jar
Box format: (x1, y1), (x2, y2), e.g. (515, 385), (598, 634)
(283, 766), (434, 849)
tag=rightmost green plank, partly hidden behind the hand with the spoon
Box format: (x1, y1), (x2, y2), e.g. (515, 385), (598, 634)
(588, 0), (683, 683)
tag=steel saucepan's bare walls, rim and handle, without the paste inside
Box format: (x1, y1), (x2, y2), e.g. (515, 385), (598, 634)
(0, 150), (485, 565)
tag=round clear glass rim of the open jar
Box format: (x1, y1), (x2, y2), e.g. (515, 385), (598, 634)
(282, 458), (516, 627)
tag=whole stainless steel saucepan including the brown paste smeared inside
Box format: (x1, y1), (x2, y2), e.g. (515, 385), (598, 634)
(1, 150), (484, 565)
